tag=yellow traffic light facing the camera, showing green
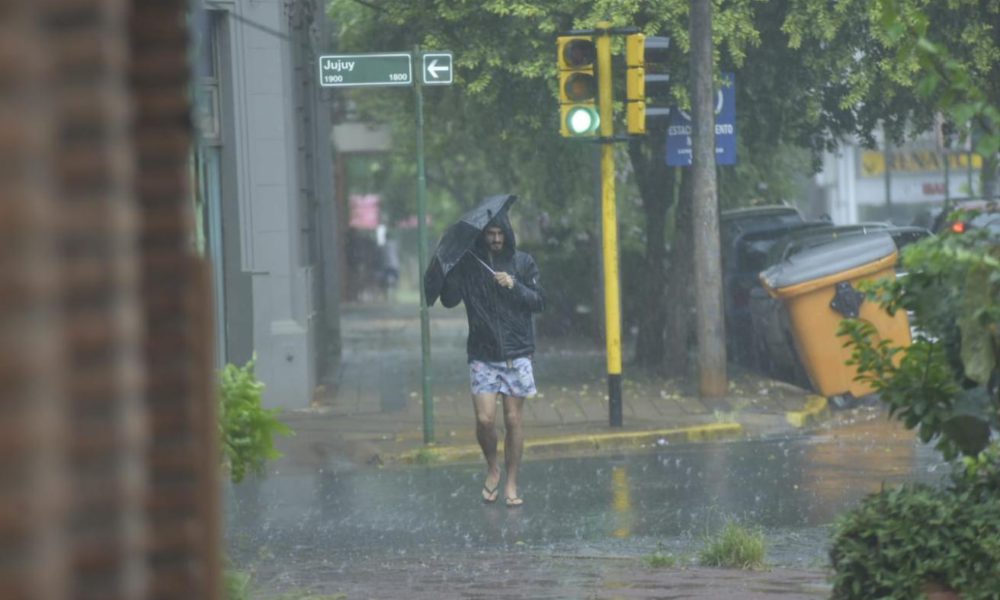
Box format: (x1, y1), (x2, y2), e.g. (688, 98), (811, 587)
(557, 35), (601, 137)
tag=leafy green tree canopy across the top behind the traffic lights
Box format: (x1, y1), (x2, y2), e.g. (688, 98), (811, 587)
(329, 0), (1000, 360)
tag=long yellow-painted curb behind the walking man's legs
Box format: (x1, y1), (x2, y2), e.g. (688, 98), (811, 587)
(385, 420), (744, 464)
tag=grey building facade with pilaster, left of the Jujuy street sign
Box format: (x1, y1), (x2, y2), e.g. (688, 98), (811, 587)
(196, 0), (339, 408)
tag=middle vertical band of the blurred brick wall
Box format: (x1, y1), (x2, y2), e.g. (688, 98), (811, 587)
(42, 0), (146, 600)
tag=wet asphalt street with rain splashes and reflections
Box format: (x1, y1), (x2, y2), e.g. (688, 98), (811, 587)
(227, 418), (947, 599)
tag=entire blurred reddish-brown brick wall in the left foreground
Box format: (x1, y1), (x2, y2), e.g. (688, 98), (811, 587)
(0, 0), (221, 600)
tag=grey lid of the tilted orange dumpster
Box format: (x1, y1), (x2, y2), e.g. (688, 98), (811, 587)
(760, 233), (896, 289)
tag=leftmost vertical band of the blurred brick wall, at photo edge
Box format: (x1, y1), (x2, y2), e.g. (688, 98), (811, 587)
(0, 2), (70, 600)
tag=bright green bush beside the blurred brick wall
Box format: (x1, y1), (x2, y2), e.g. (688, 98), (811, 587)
(219, 357), (293, 483)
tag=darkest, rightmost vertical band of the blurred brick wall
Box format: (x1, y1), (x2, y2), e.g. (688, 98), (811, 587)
(130, 0), (222, 598)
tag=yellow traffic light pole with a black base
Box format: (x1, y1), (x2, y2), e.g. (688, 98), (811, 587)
(596, 22), (622, 427)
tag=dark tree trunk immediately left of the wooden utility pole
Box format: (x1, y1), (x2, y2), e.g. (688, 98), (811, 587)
(663, 169), (694, 378)
